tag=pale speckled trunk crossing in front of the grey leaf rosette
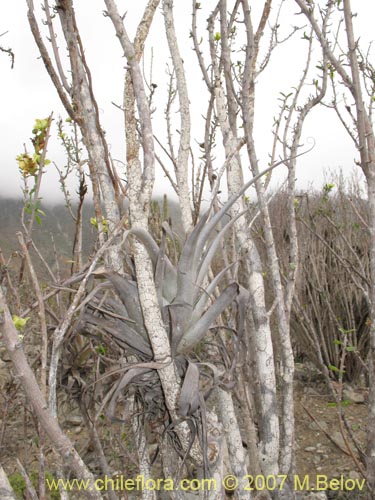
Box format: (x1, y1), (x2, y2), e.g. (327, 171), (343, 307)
(106, 0), (187, 490)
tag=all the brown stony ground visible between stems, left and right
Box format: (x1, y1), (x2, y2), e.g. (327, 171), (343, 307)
(0, 363), (367, 500)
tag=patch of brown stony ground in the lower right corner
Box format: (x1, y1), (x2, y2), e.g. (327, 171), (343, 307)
(295, 365), (367, 500)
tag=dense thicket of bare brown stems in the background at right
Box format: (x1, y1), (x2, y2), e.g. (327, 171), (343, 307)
(272, 179), (369, 382)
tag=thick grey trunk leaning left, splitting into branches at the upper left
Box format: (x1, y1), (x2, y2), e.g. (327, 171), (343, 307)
(26, 0), (123, 272)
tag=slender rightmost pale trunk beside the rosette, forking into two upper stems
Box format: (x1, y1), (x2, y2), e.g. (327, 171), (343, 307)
(241, 0), (329, 475)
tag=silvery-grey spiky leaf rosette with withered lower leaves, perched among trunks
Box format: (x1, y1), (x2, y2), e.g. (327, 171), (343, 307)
(77, 179), (263, 464)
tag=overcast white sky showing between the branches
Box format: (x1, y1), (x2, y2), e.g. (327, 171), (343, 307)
(0, 0), (375, 201)
